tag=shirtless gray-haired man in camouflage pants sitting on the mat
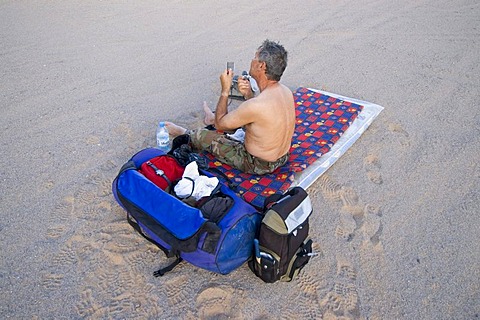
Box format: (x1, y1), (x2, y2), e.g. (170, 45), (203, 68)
(166, 40), (295, 174)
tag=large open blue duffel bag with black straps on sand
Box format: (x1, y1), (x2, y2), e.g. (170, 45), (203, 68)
(112, 148), (261, 276)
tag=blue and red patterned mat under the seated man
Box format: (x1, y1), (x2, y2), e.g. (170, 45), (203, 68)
(203, 88), (363, 208)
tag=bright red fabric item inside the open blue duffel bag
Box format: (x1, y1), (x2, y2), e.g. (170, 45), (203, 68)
(139, 155), (185, 190)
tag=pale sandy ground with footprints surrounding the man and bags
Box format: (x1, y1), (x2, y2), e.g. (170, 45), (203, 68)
(0, 0), (480, 319)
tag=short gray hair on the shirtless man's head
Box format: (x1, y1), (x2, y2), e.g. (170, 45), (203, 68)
(257, 39), (288, 81)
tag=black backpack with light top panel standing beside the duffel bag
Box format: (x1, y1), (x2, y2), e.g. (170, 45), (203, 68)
(248, 187), (315, 283)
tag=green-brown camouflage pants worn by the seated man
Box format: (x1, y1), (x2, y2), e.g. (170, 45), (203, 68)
(188, 129), (289, 174)
